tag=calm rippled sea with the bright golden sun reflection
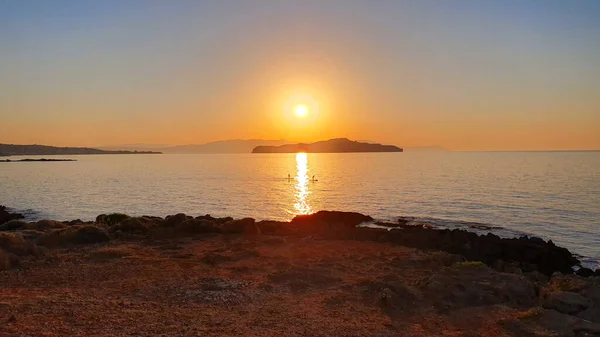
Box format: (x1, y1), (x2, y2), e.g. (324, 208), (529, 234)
(0, 152), (600, 265)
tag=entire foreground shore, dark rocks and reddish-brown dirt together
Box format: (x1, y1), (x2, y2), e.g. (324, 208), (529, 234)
(0, 207), (600, 336)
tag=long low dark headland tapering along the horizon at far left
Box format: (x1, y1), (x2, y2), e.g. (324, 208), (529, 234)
(0, 144), (160, 156)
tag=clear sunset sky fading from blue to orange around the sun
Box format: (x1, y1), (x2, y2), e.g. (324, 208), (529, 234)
(0, 0), (600, 151)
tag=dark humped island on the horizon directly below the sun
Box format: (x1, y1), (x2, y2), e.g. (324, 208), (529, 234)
(252, 138), (403, 153)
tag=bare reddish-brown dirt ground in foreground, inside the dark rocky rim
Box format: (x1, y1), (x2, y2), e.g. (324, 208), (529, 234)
(0, 234), (580, 337)
